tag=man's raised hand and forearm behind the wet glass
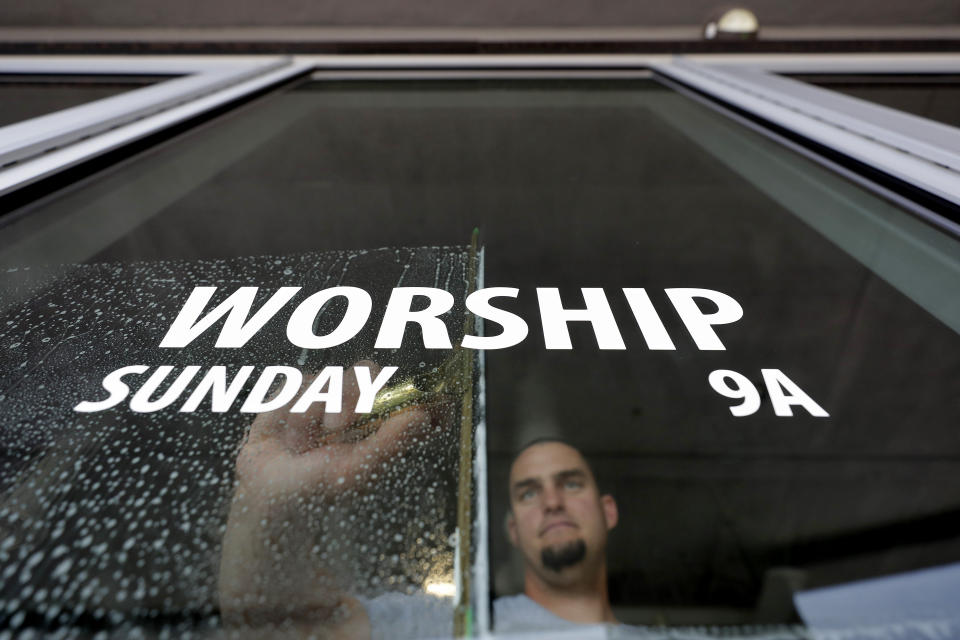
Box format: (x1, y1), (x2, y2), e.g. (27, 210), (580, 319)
(219, 361), (431, 636)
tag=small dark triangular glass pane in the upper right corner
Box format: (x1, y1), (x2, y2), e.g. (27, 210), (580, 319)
(790, 73), (960, 127)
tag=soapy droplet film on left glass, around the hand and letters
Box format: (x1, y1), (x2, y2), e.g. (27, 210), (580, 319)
(0, 247), (469, 636)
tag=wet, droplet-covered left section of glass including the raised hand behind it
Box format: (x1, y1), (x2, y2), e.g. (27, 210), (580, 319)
(0, 247), (469, 636)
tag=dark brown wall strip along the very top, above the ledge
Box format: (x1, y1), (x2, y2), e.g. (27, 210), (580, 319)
(0, 0), (960, 27)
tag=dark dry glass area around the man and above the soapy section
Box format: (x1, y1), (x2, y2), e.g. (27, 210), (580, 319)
(1, 80), (960, 624)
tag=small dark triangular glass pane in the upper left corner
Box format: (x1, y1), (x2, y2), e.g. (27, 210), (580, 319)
(0, 74), (168, 127)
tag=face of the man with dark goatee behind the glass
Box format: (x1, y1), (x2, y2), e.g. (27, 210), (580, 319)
(508, 442), (617, 579)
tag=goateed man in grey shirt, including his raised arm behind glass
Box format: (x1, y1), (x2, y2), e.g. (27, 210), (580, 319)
(219, 363), (617, 638)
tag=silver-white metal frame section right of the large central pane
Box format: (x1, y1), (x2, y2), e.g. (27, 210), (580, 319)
(655, 55), (960, 225)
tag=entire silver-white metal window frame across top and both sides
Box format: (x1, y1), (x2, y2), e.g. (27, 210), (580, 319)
(7, 54), (960, 220)
